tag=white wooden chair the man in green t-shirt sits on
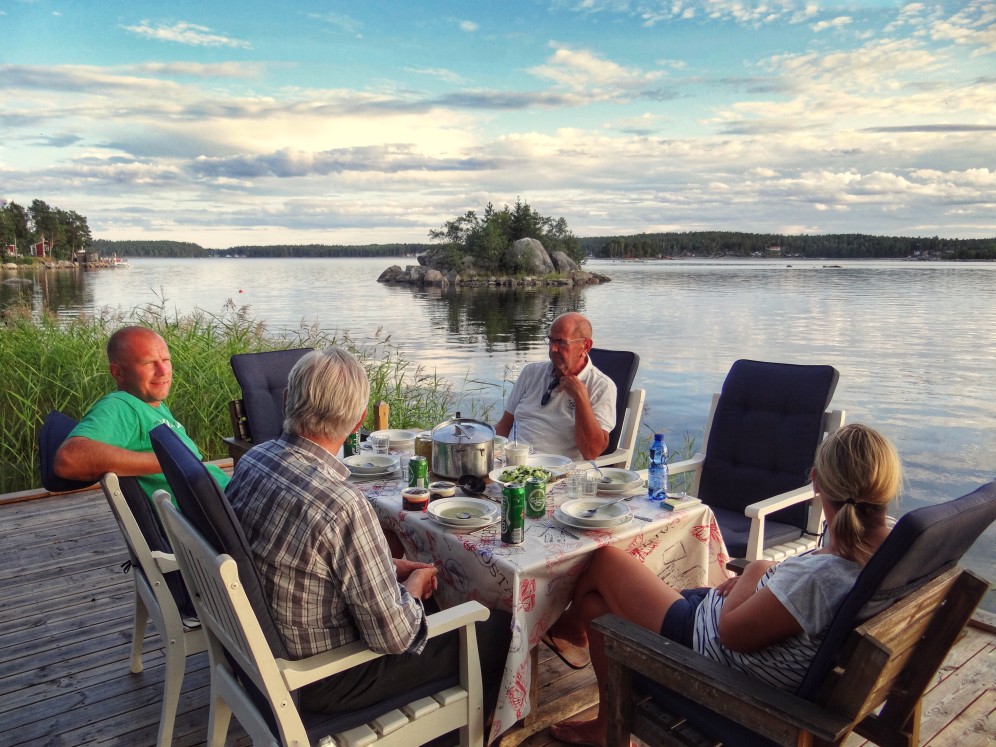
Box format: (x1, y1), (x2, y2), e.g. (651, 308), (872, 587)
(38, 410), (207, 747)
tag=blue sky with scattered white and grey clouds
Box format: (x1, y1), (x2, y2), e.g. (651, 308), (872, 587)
(0, 0), (996, 248)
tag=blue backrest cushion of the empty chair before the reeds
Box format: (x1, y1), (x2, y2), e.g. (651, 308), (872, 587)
(230, 348), (314, 444)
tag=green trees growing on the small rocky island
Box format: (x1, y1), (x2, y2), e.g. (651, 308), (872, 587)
(428, 200), (585, 275)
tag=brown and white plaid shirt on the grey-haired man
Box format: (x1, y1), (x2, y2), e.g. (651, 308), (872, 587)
(226, 433), (426, 658)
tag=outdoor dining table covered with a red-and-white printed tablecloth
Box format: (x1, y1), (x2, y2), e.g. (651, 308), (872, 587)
(355, 476), (728, 741)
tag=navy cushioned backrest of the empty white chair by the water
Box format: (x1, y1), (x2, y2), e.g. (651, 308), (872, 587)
(698, 360), (839, 529)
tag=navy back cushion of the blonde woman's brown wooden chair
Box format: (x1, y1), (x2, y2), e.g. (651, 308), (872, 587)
(797, 481), (996, 700)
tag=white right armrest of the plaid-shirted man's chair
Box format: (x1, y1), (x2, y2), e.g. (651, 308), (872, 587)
(276, 602), (491, 691)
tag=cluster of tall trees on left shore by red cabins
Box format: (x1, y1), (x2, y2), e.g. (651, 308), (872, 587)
(0, 200), (93, 259)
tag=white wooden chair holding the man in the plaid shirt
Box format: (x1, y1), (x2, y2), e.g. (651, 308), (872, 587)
(152, 426), (489, 747)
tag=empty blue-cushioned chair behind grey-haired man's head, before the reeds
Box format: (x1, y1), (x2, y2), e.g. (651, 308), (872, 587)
(224, 348), (313, 464)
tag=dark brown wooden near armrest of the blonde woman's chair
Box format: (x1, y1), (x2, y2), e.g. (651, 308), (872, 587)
(593, 615), (851, 745)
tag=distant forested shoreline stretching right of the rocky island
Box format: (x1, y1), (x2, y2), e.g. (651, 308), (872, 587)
(580, 231), (996, 259)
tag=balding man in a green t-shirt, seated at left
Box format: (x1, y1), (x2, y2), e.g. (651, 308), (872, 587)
(54, 327), (229, 497)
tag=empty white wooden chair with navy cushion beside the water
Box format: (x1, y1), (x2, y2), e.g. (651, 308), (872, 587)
(670, 360), (844, 560)
